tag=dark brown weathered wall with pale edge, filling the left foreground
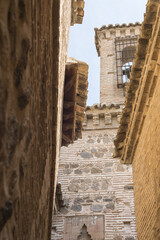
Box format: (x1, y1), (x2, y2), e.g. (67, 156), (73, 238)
(0, 0), (71, 240)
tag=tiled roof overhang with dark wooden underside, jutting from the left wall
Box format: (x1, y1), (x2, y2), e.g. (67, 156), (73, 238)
(62, 59), (88, 146)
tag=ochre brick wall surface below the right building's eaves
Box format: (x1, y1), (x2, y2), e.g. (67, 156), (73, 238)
(133, 69), (160, 240)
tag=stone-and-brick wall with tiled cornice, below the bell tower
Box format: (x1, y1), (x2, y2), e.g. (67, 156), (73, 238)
(52, 104), (136, 240)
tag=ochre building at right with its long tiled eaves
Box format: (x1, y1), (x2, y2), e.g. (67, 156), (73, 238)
(115, 0), (160, 240)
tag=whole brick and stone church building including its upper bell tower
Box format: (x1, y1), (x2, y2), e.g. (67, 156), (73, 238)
(52, 23), (140, 240)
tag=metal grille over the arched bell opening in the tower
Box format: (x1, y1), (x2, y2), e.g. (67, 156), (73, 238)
(115, 36), (138, 89)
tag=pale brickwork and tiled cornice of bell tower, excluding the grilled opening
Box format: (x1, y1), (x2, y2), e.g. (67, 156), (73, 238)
(95, 23), (140, 104)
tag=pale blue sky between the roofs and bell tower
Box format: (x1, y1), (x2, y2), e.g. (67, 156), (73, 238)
(68, 0), (147, 106)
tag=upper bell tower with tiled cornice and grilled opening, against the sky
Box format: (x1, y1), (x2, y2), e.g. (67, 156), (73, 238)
(95, 22), (141, 104)
